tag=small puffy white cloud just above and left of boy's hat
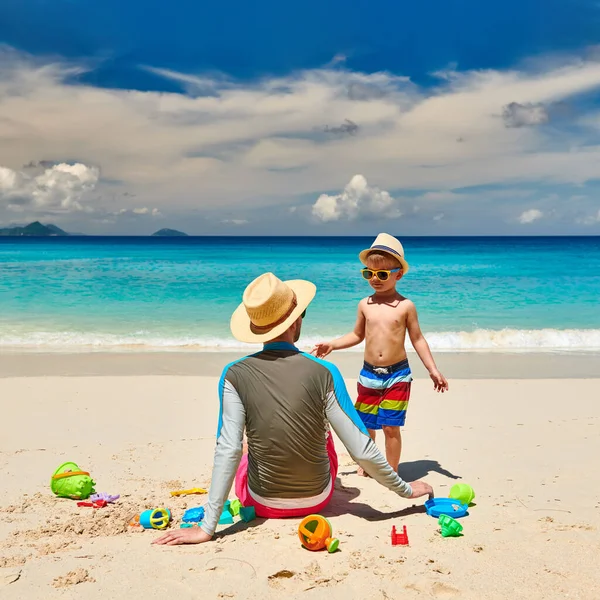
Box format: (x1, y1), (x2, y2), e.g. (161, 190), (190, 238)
(312, 175), (401, 222)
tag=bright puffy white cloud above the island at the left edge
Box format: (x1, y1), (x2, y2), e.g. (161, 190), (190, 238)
(0, 163), (100, 213)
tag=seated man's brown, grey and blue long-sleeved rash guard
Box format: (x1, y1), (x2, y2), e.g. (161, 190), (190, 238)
(202, 342), (412, 535)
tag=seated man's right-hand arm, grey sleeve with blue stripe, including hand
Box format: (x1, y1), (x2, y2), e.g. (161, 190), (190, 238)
(325, 364), (433, 498)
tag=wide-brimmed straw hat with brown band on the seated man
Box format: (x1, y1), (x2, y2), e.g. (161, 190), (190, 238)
(230, 273), (317, 343)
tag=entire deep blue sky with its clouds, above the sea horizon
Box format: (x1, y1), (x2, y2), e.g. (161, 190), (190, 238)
(0, 0), (600, 235)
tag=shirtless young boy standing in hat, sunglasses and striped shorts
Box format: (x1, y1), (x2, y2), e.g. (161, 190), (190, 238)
(312, 233), (448, 475)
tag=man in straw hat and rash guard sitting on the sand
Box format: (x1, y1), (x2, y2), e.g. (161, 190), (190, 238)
(154, 273), (433, 545)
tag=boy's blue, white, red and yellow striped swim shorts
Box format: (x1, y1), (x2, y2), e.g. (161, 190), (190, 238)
(354, 359), (412, 429)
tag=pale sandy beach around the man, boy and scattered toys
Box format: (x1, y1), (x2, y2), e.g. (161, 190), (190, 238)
(0, 353), (600, 600)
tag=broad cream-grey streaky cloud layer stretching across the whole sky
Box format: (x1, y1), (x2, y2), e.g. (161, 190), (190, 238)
(0, 47), (600, 229)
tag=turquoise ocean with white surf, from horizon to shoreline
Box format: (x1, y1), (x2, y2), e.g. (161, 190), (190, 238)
(0, 237), (600, 352)
